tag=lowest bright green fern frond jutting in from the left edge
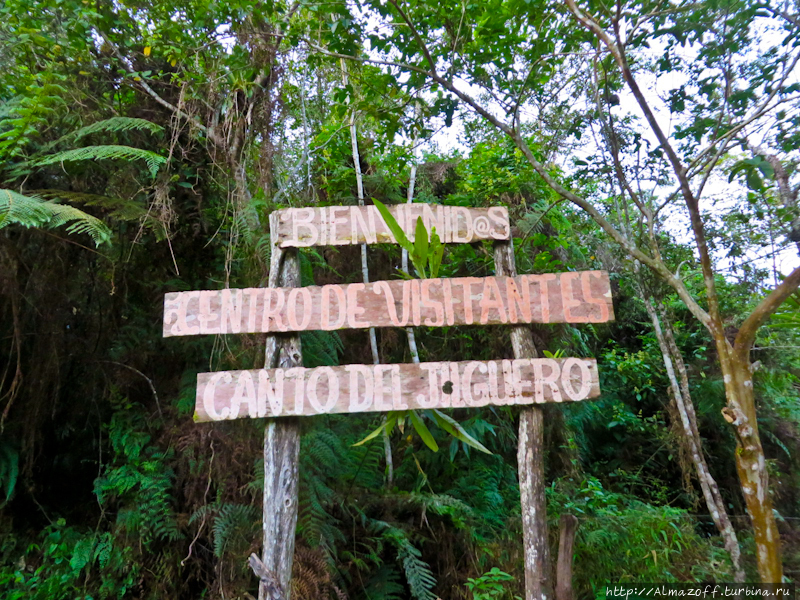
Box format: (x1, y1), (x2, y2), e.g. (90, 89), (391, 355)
(0, 189), (111, 246)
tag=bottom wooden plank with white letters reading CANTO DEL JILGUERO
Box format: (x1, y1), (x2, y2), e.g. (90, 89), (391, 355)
(195, 358), (600, 422)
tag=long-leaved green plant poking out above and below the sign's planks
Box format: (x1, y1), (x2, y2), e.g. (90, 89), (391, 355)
(354, 200), (491, 454)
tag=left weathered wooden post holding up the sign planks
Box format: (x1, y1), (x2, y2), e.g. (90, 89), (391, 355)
(256, 213), (303, 600)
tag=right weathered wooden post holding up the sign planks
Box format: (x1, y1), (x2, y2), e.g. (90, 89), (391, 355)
(494, 240), (550, 600)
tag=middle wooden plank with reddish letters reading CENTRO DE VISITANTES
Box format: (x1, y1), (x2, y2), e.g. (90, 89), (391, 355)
(164, 271), (614, 337)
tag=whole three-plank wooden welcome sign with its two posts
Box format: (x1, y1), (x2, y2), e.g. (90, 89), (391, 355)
(163, 204), (613, 600)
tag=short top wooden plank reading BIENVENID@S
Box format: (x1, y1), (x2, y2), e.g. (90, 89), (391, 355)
(275, 203), (511, 248)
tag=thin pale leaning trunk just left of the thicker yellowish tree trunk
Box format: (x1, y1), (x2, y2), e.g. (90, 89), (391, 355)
(645, 298), (745, 583)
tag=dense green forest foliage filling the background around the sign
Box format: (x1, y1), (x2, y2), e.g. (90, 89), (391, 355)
(0, 0), (800, 600)
